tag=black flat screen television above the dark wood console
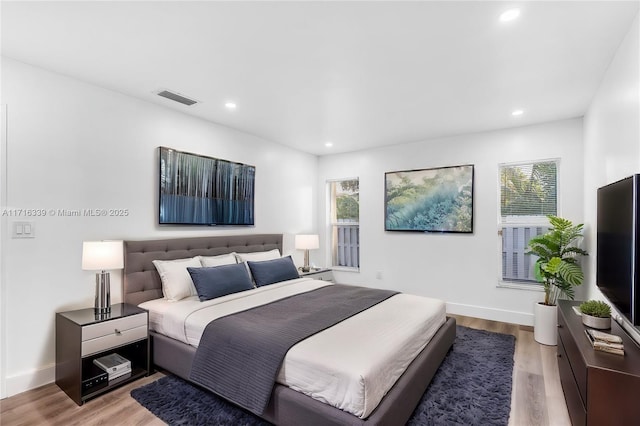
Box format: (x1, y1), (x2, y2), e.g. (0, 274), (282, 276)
(596, 175), (640, 328)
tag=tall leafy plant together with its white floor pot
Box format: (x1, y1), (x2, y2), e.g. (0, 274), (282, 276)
(527, 216), (588, 345)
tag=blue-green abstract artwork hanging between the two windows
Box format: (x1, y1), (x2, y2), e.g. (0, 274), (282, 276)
(384, 164), (474, 234)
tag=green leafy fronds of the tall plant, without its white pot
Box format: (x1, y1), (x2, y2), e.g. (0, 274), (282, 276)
(527, 216), (588, 306)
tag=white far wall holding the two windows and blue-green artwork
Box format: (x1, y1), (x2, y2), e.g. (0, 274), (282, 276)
(318, 118), (583, 324)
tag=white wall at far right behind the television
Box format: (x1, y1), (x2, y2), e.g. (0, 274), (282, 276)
(584, 11), (640, 299)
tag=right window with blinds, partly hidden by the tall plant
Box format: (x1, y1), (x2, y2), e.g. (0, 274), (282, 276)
(498, 160), (558, 284)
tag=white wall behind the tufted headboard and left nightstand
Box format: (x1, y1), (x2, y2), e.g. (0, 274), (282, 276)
(0, 59), (318, 396)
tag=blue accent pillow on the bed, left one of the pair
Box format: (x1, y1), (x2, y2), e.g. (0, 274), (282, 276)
(187, 263), (253, 302)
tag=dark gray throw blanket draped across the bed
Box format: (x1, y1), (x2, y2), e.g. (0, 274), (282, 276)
(190, 284), (397, 415)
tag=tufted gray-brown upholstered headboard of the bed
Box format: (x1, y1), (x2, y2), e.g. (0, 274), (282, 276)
(122, 234), (282, 305)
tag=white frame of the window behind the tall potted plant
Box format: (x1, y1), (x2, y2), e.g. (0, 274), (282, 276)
(496, 157), (562, 292)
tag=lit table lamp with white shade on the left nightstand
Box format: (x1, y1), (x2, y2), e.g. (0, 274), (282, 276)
(82, 241), (124, 314)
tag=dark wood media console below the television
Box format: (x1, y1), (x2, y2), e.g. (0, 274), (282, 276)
(558, 300), (640, 426)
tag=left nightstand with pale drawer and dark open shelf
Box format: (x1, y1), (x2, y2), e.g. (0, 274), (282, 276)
(56, 303), (150, 405)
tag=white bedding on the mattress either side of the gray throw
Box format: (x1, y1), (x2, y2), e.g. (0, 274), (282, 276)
(140, 278), (445, 418)
